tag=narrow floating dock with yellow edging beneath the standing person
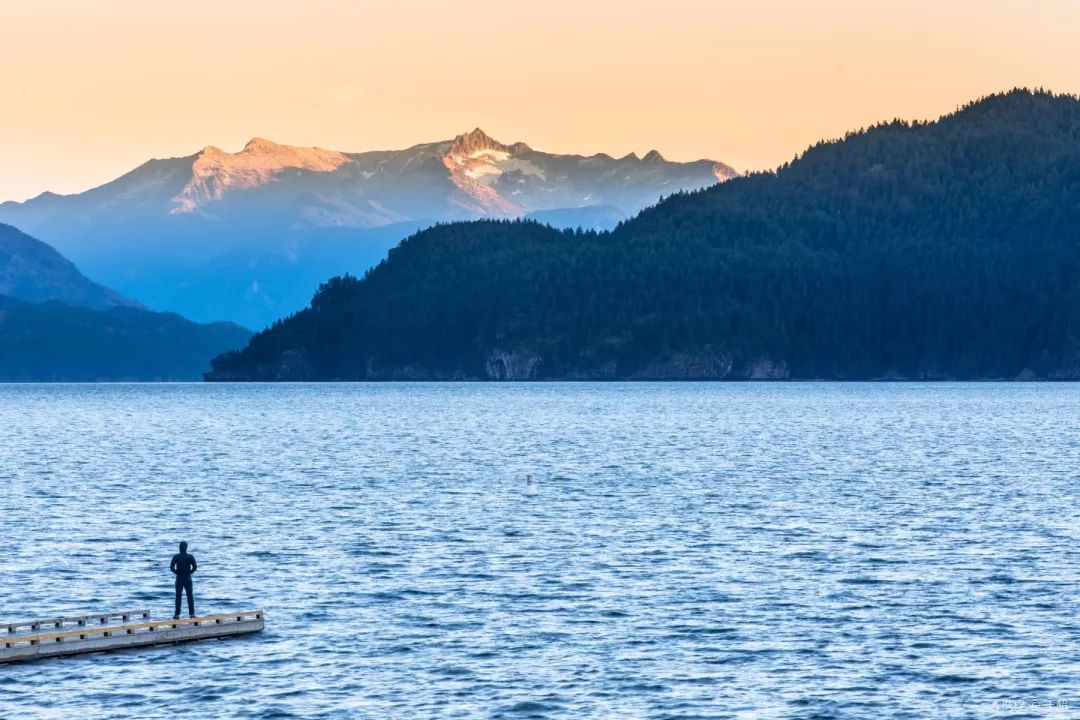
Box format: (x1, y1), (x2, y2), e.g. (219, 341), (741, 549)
(0, 610), (262, 664)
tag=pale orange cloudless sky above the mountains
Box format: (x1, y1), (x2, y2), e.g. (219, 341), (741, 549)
(0, 0), (1080, 200)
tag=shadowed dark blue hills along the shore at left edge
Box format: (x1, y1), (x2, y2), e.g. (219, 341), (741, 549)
(0, 225), (251, 382)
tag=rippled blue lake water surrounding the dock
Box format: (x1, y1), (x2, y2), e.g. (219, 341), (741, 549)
(0, 383), (1080, 720)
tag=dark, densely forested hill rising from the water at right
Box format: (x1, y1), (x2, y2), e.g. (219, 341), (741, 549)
(207, 91), (1080, 380)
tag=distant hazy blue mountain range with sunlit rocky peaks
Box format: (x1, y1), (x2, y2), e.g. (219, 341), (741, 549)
(0, 128), (737, 327)
